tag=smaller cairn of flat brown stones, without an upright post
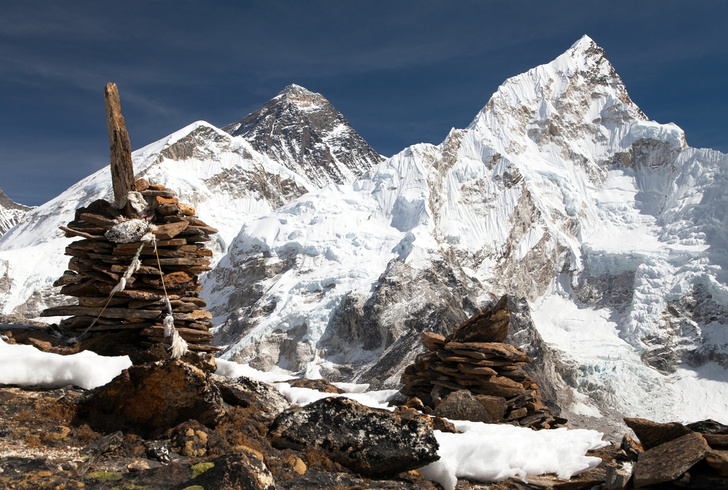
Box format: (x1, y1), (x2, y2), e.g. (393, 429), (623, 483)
(401, 296), (566, 429)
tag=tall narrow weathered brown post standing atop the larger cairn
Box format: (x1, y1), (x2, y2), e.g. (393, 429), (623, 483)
(104, 82), (135, 204)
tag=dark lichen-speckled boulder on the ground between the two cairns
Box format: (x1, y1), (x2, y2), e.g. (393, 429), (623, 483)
(269, 397), (439, 476)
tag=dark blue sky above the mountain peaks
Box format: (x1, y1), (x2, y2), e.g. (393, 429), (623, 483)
(0, 0), (728, 205)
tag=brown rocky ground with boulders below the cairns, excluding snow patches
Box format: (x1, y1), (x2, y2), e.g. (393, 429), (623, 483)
(0, 329), (728, 489)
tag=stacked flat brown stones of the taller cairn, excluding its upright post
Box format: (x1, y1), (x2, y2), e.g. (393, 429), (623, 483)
(43, 179), (218, 352)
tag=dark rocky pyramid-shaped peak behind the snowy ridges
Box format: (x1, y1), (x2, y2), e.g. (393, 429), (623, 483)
(223, 84), (384, 187)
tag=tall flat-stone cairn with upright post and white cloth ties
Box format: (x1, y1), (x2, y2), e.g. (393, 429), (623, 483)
(42, 82), (218, 361)
